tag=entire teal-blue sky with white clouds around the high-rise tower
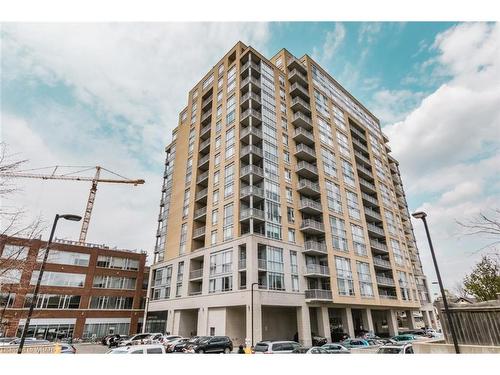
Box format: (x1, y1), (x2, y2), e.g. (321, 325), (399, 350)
(0, 22), (500, 291)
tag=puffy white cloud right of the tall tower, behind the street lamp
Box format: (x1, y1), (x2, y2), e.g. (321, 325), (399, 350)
(384, 23), (500, 286)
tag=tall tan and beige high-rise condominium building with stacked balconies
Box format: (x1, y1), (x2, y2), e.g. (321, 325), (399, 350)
(147, 42), (435, 345)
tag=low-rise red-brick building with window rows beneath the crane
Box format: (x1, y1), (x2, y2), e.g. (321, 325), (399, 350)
(0, 236), (149, 340)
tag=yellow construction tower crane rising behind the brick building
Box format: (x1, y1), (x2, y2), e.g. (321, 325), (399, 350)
(0, 165), (144, 243)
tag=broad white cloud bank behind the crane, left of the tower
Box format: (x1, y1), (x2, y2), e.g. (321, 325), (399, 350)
(1, 23), (268, 262)
